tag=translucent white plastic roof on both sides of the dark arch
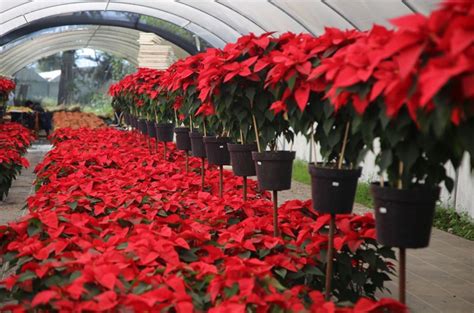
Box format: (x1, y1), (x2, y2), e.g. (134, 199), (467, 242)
(0, 0), (440, 74)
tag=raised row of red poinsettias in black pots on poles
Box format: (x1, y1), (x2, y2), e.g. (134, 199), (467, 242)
(111, 2), (474, 248)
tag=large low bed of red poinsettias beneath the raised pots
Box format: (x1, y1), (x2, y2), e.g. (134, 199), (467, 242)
(0, 129), (405, 312)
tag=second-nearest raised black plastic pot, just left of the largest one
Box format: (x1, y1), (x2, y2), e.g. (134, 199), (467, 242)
(308, 163), (362, 214)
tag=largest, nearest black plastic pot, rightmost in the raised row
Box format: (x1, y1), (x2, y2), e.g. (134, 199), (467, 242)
(370, 183), (440, 248)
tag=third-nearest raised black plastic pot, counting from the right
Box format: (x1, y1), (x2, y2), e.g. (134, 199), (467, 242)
(252, 151), (296, 191)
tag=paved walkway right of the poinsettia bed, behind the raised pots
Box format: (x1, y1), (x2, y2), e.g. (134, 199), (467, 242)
(279, 181), (474, 313)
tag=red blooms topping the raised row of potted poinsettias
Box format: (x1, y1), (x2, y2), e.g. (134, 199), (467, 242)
(111, 0), (474, 124)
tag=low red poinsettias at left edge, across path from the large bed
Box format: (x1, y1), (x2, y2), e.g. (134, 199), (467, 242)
(0, 123), (33, 200)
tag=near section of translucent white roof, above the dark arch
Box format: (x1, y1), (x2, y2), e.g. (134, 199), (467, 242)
(0, 0), (439, 47)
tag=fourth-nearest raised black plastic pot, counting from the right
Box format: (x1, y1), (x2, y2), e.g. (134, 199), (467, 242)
(227, 143), (257, 177)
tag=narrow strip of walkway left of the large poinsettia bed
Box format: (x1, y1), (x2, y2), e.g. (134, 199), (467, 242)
(0, 144), (51, 225)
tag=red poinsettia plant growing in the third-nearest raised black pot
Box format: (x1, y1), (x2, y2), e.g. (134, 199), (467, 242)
(194, 33), (293, 150)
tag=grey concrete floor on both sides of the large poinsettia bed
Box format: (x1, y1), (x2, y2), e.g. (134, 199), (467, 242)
(0, 152), (474, 313)
